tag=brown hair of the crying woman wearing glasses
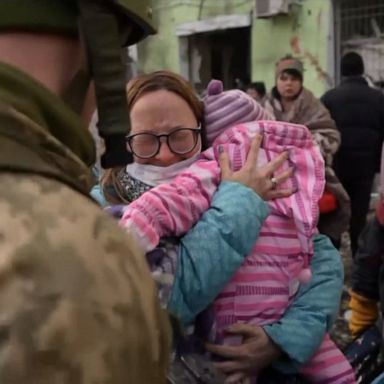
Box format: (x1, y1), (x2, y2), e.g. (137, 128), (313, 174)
(101, 71), (207, 203)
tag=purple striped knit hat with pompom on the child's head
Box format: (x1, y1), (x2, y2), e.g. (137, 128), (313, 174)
(203, 80), (271, 145)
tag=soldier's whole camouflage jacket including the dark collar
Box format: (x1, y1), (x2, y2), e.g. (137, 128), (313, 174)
(0, 65), (170, 384)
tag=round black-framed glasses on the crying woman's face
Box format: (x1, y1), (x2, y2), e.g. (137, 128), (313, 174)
(126, 125), (201, 159)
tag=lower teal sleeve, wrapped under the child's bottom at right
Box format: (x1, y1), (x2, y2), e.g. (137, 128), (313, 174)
(263, 235), (344, 371)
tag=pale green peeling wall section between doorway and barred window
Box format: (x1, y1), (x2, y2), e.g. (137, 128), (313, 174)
(252, 0), (333, 96)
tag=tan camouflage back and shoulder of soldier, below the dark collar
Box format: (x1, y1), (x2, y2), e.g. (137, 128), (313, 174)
(0, 173), (170, 384)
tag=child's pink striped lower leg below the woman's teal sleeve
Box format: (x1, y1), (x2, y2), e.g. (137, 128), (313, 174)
(300, 334), (356, 384)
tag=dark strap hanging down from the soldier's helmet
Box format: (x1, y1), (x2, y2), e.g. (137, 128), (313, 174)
(78, 0), (132, 168)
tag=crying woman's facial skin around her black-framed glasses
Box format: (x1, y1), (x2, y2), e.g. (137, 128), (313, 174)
(130, 90), (201, 167)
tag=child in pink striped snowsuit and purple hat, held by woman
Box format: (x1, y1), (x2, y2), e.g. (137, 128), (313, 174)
(121, 82), (355, 384)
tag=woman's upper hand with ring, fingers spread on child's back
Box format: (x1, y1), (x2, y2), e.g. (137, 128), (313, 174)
(219, 135), (296, 200)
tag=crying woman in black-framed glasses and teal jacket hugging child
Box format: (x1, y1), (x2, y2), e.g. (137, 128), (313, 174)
(92, 72), (348, 382)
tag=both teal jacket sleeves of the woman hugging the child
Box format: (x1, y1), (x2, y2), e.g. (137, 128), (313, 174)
(168, 182), (344, 372)
